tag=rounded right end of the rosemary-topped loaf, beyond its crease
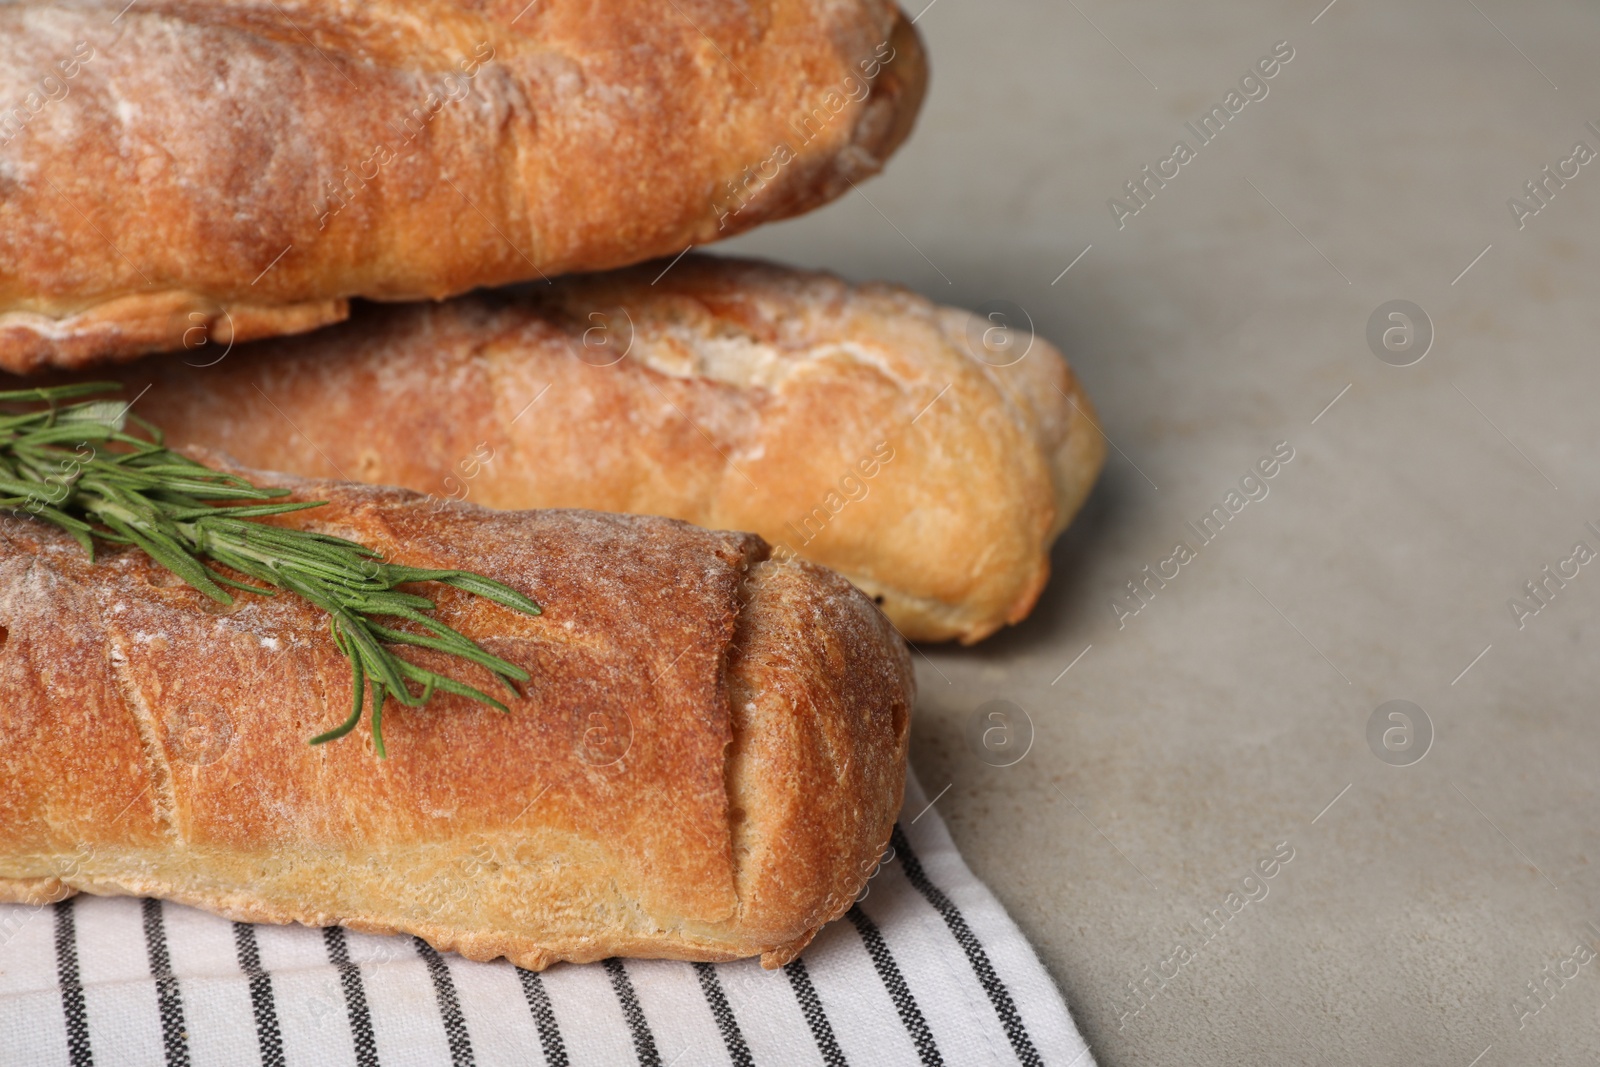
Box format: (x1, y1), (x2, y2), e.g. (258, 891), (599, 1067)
(728, 560), (915, 966)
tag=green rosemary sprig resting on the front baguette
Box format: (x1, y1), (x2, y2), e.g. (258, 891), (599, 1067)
(0, 382), (539, 758)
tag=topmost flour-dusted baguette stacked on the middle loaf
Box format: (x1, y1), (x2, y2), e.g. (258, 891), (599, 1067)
(0, 0), (925, 371)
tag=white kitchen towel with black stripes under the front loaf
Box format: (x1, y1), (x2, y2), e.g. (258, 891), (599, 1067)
(0, 779), (1093, 1067)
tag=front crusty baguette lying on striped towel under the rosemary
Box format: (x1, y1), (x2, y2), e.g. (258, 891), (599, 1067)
(0, 477), (914, 968)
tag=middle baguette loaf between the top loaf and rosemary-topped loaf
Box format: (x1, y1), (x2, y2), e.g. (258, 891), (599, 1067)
(93, 256), (1104, 641)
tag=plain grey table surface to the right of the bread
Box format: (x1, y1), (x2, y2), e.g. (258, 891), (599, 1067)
(722, 0), (1600, 1067)
